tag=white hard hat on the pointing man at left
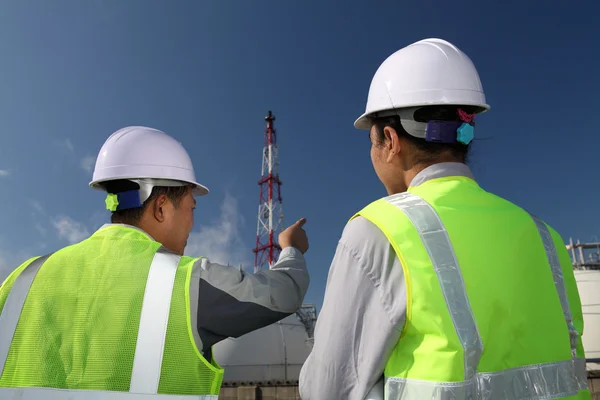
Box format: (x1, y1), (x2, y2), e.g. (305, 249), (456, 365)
(90, 126), (208, 208)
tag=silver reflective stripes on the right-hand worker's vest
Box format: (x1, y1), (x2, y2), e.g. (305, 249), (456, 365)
(385, 192), (587, 400)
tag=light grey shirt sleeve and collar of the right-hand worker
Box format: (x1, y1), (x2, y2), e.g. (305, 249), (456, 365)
(300, 163), (473, 400)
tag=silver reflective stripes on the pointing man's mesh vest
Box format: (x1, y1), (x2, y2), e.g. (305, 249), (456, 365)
(0, 247), (190, 399)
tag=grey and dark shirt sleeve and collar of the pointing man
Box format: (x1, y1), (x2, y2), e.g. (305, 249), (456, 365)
(101, 224), (310, 359)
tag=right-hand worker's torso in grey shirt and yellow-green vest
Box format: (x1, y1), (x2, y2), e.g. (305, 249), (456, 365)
(301, 163), (586, 399)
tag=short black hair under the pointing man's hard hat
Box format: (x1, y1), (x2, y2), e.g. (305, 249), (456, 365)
(103, 179), (190, 226)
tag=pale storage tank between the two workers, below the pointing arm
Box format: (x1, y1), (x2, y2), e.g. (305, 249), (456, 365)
(213, 306), (316, 384)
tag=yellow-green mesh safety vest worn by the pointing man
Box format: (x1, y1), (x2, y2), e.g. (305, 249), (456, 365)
(0, 225), (223, 400)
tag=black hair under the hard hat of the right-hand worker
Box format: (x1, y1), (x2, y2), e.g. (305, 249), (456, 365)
(371, 105), (481, 164)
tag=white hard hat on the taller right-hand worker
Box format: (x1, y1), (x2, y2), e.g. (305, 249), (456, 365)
(354, 39), (490, 131)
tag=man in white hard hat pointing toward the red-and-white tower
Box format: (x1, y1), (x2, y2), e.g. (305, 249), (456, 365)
(0, 127), (309, 400)
